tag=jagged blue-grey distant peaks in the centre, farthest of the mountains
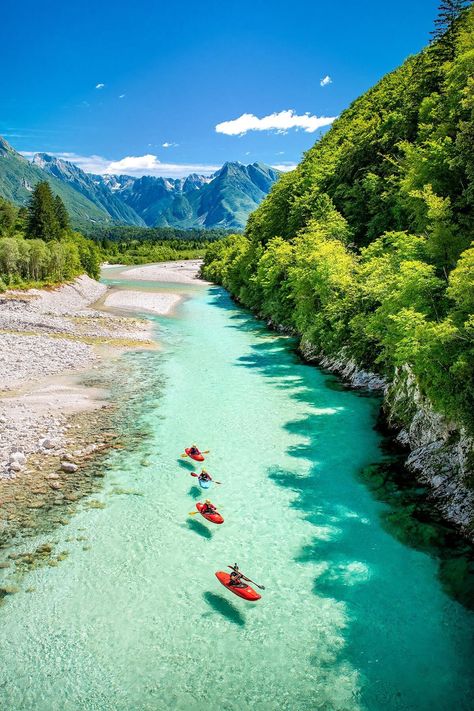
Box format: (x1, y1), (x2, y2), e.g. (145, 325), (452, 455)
(97, 162), (280, 230)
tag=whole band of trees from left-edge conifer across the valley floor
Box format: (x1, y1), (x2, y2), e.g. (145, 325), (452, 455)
(0, 189), (224, 291)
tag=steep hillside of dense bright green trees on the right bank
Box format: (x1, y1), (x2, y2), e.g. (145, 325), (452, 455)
(204, 0), (474, 431)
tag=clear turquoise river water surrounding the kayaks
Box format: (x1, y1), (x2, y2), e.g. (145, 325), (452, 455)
(0, 282), (474, 711)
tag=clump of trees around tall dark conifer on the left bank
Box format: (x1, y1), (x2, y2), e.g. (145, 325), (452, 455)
(0, 181), (101, 291)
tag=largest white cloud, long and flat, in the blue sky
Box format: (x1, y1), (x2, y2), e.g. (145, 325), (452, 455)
(216, 109), (337, 136)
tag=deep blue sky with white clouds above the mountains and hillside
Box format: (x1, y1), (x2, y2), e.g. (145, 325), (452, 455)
(0, 0), (438, 177)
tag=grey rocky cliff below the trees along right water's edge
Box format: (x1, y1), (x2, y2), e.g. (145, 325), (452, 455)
(300, 342), (474, 540)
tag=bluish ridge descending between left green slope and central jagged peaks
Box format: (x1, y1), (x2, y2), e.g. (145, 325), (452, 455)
(32, 153), (145, 226)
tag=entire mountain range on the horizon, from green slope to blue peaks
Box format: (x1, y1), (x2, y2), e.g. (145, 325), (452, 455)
(0, 137), (280, 230)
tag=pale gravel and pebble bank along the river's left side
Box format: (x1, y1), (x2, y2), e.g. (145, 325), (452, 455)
(0, 263), (204, 543)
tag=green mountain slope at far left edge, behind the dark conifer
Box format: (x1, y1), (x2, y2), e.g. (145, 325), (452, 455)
(0, 137), (112, 229)
